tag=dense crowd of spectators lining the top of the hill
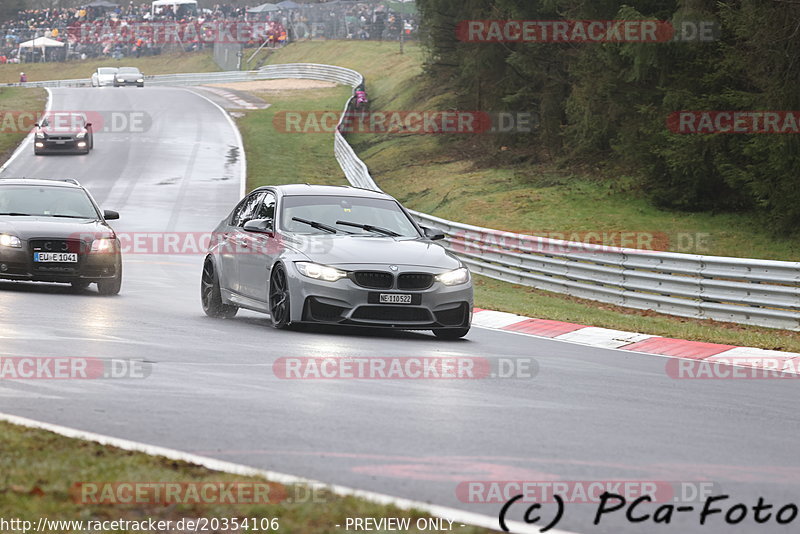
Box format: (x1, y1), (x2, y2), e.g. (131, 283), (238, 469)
(0, 0), (417, 63)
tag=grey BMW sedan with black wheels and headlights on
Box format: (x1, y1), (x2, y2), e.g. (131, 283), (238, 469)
(201, 184), (473, 339)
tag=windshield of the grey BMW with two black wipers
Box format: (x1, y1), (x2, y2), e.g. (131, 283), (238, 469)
(281, 195), (420, 237)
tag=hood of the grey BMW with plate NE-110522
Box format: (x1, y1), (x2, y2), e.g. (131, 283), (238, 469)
(282, 235), (461, 271)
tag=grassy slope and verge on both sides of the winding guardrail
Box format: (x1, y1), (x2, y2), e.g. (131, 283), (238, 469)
(234, 41), (800, 351)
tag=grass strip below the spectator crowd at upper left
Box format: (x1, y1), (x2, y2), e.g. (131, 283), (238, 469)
(0, 51), (220, 83)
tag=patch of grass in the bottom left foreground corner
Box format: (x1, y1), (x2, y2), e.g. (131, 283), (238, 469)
(0, 422), (490, 534)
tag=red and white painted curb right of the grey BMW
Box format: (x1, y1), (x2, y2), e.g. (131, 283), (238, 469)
(472, 308), (800, 375)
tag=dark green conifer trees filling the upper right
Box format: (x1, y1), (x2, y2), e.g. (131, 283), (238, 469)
(417, 0), (800, 234)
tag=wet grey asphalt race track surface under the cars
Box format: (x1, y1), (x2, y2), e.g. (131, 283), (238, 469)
(0, 87), (800, 534)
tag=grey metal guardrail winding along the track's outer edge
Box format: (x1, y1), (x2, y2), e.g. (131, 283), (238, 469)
(13, 63), (800, 330)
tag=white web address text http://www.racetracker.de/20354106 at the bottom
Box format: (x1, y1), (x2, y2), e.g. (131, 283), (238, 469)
(0, 517), (280, 534)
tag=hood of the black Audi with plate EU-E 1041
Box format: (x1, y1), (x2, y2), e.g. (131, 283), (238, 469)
(0, 217), (114, 241)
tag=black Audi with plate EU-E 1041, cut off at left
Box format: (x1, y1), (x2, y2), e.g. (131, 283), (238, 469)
(0, 178), (122, 295)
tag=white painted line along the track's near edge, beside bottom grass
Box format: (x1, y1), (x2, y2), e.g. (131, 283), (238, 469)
(0, 413), (577, 534)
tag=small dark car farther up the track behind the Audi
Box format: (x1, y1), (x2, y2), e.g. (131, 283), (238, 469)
(33, 112), (94, 155)
